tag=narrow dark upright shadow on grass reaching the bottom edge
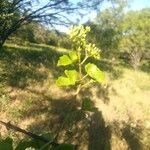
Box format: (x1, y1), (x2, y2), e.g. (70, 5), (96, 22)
(88, 111), (111, 150)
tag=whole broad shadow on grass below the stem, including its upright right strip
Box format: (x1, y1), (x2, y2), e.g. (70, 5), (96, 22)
(15, 87), (111, 150)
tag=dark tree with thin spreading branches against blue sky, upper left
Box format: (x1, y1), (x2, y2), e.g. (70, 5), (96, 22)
(0, 0), (103, 47)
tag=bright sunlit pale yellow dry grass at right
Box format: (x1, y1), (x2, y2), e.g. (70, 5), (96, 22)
(96, 67), (150, 150)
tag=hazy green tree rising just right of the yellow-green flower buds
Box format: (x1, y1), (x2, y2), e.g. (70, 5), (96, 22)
(87, 0), (127, 58)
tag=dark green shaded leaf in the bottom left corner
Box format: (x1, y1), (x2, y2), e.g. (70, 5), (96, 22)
(0, 138), (13, 150)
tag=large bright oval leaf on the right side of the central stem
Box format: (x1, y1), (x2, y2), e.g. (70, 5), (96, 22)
(85, 63), (104, 83)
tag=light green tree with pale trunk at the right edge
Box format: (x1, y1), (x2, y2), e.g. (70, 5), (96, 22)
(120, 9), (150, 69)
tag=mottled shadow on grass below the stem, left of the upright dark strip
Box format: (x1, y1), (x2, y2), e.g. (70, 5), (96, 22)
(22, 96), (88, 148)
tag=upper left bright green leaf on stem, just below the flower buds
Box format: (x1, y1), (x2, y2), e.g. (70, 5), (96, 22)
(57, 55), (72, 66)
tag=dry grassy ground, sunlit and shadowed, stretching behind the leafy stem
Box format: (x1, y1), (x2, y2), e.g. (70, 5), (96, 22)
(0, 44), (150, 150)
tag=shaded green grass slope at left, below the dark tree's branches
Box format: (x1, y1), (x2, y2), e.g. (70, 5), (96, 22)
(0, 43), (61, 88)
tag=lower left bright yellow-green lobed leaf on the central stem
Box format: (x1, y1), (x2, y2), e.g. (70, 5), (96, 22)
(56, 70), (77, 86)
